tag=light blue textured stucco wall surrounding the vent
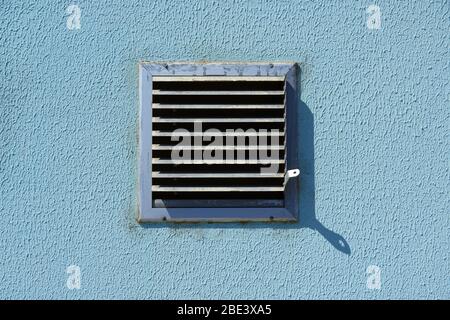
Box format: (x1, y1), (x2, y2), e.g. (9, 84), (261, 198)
(0, 0), (450, 299)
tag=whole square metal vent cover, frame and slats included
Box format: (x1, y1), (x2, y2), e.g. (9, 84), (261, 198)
(139, 63), (299, 222)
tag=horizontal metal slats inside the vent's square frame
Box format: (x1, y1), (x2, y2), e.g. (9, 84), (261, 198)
(152, 76), (285, 208)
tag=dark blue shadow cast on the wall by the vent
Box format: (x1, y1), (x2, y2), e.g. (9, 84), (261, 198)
(141, 70), (351, 255)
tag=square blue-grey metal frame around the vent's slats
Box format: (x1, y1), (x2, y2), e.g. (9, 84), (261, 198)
(137, 62), (299, 223)
